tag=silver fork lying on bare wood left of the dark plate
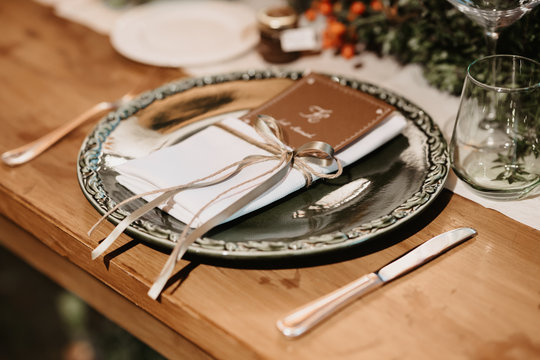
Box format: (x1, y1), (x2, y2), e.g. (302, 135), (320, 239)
(2, 93), (134, 166)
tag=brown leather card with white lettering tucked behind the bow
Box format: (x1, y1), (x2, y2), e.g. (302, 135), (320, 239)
(241, 74), (395, 151)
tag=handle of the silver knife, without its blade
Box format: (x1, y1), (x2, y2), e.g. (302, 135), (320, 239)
(276, 273), (383, 338)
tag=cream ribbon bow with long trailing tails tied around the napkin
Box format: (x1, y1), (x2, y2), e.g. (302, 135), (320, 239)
(88, 115), (343, 299)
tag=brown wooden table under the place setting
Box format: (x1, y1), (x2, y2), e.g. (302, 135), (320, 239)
(0, 0), (540, 359)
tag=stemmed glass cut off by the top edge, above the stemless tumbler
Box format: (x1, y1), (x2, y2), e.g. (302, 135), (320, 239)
(448, 0), (540, 55)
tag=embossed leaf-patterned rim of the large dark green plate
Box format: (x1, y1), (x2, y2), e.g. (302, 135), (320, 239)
(77, 69), (450, 260)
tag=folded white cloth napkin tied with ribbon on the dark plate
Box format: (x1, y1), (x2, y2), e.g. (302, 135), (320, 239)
(115, 112), (406, 227)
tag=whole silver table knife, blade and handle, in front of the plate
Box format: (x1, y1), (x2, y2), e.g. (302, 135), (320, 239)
(276, 228), (476, 338)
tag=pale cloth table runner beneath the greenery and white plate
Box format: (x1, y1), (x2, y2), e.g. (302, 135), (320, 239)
(36, 0), (540, 230)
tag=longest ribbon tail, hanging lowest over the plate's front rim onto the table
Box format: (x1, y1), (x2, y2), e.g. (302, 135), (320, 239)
(148, 158), (292, 300)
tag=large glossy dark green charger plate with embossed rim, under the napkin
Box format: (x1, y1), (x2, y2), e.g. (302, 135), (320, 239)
(77, 70), (449, 260)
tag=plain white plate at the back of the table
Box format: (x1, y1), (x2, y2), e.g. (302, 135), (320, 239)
(111, 0), (259, 67)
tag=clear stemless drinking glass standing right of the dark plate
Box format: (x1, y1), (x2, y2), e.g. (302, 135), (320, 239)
(450, 55), (540, 200)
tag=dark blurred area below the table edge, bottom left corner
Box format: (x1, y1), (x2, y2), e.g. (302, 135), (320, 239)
(0, 247), (164, 360)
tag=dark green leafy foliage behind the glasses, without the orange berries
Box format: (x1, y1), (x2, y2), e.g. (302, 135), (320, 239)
(291, 0), (540, 95)
